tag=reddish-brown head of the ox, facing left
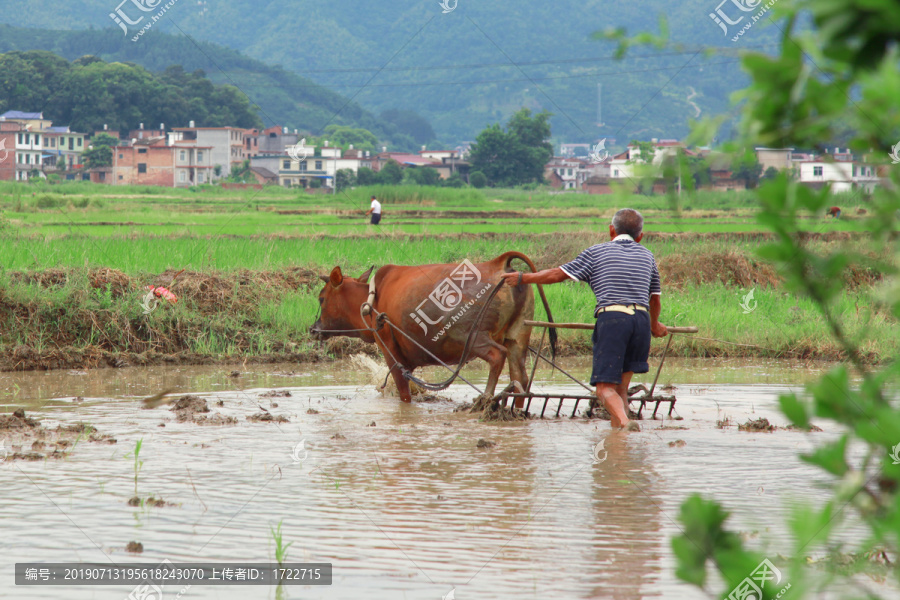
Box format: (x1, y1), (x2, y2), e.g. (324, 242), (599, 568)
(310, 266), (375, 340)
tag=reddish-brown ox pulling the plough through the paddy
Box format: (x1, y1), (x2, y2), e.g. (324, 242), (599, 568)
(312, 252), (556, 403)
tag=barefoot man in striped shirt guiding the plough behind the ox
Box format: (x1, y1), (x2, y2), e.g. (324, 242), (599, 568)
(502, 208), (668, 429)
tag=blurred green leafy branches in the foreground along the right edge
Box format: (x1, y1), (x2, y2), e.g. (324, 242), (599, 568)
(604, 0), (900, 599)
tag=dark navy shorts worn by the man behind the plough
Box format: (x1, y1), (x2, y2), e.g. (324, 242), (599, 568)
(591, 310), (651, 385)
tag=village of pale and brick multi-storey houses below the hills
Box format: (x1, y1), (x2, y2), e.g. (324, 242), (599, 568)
(0, 111), (885, 194)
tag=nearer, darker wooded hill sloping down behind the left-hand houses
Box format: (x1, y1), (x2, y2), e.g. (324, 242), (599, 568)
(0, 25), (414, 149)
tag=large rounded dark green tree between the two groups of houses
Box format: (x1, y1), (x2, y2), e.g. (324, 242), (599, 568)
(469, 108), (553, 187)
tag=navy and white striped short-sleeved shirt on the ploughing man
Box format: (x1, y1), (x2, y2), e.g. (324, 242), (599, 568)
(560, 234), (662, 310)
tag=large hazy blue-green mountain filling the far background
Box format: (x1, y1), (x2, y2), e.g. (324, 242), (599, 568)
(0, 0), (779, 144)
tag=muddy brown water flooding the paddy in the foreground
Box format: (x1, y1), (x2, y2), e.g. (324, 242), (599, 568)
(0, 360), (896, 600)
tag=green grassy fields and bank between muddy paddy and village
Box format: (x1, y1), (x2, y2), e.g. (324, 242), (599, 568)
(0, 184), (900, 370)
